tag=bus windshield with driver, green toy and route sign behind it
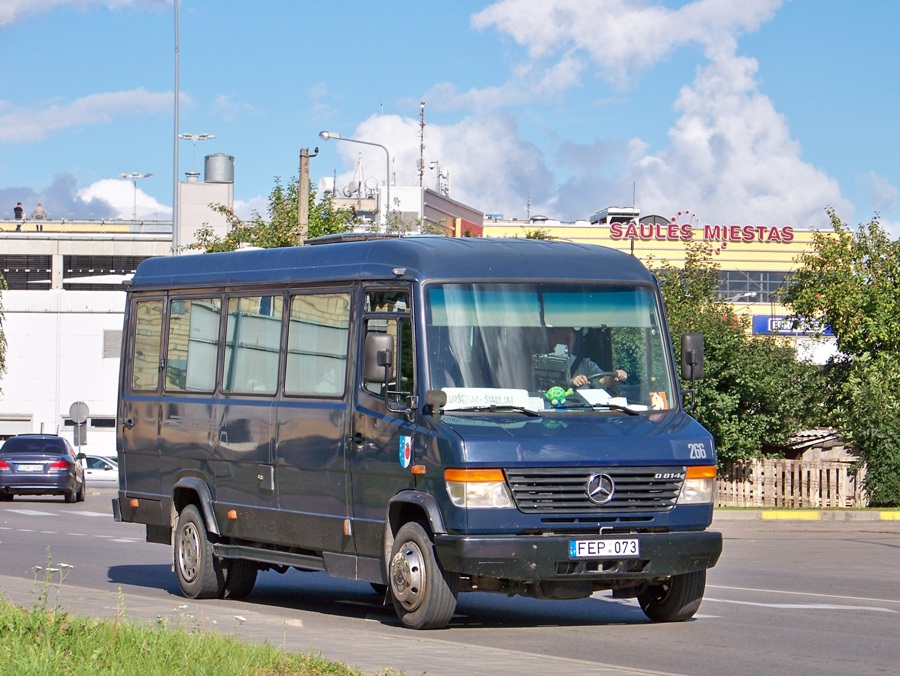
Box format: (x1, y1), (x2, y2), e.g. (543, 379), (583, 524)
(425, 283), (676, 412)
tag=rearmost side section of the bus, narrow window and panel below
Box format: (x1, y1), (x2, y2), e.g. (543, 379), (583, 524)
(118, 296), (165, 496)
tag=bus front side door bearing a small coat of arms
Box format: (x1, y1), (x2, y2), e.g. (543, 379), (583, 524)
(350, 285), (415, 563)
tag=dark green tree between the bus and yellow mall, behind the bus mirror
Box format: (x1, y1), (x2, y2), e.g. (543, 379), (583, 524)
(651, 242), (821, 460)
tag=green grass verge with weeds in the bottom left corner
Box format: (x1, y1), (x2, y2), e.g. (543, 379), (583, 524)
(0, 552), (372, 676)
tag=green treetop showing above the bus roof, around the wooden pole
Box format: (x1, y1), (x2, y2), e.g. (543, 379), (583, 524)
(188, 178), (354, 252)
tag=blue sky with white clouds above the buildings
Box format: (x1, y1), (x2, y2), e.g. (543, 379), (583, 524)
(0, 0), (900, 237)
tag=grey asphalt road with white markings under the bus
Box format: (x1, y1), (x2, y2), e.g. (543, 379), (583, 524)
(0, 490), (900, 676)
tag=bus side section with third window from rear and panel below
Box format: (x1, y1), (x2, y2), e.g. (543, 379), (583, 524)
(214, 294), (284, 542)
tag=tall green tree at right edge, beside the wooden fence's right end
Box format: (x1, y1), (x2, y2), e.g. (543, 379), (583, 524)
(784, 209), (900, 506)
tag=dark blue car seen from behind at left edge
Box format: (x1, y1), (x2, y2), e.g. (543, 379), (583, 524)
(0, 434), (85, 502)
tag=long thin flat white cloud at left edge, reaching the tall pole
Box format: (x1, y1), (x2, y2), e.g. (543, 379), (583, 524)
(0, 88), (177, 143)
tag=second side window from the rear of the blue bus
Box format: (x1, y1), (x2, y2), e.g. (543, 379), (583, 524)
(166, 298), (222, 392)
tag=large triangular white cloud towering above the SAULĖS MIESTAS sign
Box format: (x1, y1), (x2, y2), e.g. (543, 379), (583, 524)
(633, 50), (852, 227)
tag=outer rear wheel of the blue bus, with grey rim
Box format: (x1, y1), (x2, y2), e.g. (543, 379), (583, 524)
(172, 505), (225, 599)
